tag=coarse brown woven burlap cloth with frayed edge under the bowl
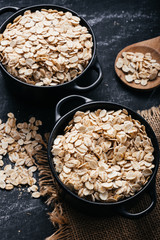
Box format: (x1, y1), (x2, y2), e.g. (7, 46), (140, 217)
(37, 106), (160, 240)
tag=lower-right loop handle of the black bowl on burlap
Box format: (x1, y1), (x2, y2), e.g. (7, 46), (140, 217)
(117, 183), (157, 219)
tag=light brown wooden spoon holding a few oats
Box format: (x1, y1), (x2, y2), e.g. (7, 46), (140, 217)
(114, 36), (160, 90)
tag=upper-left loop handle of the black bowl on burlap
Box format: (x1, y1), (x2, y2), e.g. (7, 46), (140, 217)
(55, 95), (92, 121)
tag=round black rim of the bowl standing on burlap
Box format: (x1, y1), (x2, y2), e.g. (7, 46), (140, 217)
(47, 101), (159, 206)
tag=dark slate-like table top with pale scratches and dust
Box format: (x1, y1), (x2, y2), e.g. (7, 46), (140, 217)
(0, 0), (160, 240)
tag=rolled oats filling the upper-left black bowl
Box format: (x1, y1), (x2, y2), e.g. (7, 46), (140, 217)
(0, 9), (93, 86)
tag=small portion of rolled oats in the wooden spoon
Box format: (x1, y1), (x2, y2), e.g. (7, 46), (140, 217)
(116, 52), (160, 86)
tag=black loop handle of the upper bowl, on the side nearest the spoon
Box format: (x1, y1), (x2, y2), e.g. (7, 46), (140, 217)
(73, 57), (102, 92)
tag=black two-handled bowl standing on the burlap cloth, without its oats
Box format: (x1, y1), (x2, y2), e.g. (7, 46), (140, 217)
(48, 95), (159, 218)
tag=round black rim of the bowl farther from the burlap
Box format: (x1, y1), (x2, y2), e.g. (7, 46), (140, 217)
(0, 4), (97, 89)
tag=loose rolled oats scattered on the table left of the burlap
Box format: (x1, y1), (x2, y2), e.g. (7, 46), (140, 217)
(0, 113), (44, 198)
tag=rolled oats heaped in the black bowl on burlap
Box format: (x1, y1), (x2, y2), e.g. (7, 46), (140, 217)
(52, 109), (154, 202)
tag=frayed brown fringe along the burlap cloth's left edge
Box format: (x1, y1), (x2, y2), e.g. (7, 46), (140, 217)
(35, 150), (71, 240)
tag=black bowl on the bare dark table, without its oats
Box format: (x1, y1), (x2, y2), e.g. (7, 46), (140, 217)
(0, 4), (102, 99)
